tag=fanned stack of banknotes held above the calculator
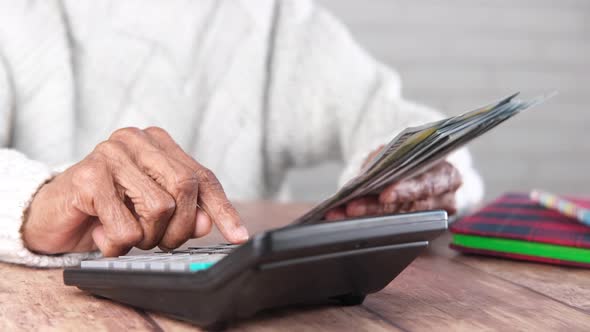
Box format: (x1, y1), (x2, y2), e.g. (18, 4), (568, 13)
(294, 93), (550, 224)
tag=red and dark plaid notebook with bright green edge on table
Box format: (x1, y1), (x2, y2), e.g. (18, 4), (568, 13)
(450, 193), (590, 268)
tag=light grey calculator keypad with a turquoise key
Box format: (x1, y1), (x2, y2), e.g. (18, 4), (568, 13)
(81, 244), (238, 272)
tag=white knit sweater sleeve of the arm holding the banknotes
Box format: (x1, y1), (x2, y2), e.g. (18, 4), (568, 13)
(267, 0), (483, 210)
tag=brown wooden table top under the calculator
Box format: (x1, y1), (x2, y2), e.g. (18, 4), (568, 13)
(0, 203), (590, 331)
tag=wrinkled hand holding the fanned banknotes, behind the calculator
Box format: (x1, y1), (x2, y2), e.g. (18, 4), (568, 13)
(325, 148), (462, 220)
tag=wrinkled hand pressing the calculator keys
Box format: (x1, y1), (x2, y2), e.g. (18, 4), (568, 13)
(21, 127), (248, 256)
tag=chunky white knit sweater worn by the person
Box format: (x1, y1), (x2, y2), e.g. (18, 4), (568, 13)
(0, 0), (482, 266)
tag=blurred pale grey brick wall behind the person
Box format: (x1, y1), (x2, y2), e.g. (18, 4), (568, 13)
(290, 0), (590, 200)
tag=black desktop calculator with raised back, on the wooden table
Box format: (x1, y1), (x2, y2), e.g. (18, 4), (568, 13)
(64, 210), (447, 329)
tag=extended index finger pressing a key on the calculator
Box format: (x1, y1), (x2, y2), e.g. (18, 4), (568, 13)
(145, 127), (249, 243)
